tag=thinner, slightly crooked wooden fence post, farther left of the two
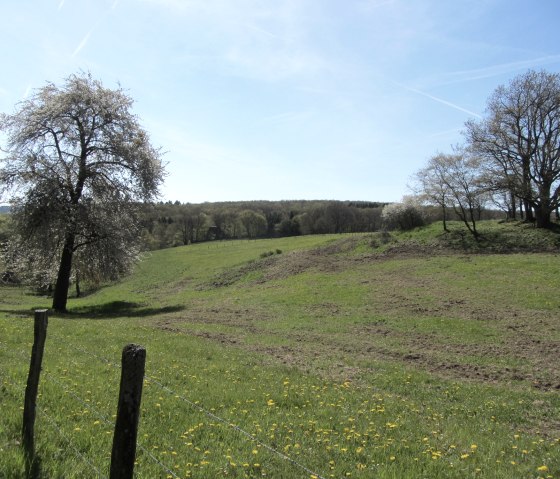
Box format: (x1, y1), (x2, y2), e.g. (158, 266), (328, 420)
(22, 309), (49, 462)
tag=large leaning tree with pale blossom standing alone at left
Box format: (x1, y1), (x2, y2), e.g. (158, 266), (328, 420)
(0, 73), (164, 311)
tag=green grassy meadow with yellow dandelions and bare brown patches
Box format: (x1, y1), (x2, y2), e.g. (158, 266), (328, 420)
(0, 223), (560, 479)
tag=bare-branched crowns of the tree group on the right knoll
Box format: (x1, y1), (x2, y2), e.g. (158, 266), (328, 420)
(415, 70), (560, 232)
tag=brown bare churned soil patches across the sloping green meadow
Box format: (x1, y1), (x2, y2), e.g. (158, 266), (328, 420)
(160, 237), (560, 391)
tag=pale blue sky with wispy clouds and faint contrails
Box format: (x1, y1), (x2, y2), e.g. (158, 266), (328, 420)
(0, 0), (560, 203)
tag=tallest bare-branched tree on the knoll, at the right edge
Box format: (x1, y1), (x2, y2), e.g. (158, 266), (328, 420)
(466, 71), (560, 227)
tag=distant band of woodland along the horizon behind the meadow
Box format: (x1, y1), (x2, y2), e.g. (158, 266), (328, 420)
(138, 200), (503, 250)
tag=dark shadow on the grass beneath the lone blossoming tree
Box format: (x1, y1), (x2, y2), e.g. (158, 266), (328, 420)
(0, 301), (185, 320)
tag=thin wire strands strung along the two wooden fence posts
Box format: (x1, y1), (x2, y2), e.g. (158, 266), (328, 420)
(0, 332), (332, 479)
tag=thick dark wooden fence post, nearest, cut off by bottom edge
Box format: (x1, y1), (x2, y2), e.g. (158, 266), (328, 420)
(109, 344), (146, 479)
